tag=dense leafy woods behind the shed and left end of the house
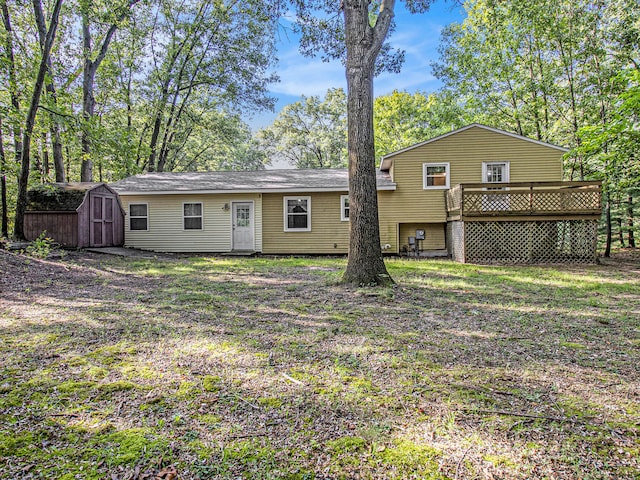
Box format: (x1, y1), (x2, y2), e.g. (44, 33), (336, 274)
(0, 0), (276, 236)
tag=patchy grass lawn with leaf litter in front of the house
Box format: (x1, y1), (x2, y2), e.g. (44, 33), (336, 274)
(0, 252), (640, 480)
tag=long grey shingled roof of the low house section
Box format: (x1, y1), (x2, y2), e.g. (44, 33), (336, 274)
(111, 169), (396, 194)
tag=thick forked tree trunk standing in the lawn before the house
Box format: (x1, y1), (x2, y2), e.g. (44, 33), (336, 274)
(343, 0), (394, 285)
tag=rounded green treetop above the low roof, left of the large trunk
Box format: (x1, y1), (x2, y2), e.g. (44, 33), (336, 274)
(257, 88), (347, 168)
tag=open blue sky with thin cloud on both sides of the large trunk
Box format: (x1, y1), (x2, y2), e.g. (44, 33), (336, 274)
(249, 0), (464, 130)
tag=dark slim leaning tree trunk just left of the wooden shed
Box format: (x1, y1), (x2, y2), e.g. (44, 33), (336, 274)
(13, 0), (62, 240)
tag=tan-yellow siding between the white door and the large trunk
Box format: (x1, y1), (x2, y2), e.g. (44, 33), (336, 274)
(262, 192), (349, 254)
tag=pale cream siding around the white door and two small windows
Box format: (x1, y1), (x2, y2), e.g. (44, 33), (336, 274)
(121, 194), (262, 253)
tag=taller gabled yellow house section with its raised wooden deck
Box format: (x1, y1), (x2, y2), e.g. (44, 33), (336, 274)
(379, 124), (601, 262)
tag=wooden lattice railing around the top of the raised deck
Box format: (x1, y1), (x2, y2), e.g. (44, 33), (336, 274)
(445, 181), (602, 217)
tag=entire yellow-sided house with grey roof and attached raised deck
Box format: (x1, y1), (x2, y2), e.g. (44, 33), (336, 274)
(112, 124), (601, 261)
